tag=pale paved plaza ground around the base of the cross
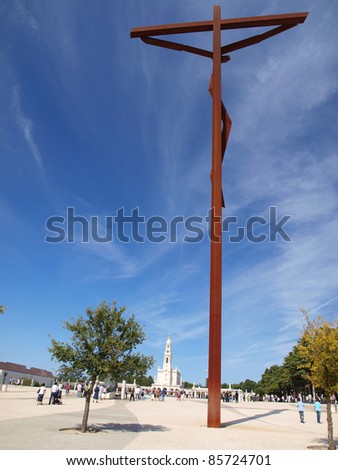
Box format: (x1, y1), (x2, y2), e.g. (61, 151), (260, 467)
(0, 386), (338, 450)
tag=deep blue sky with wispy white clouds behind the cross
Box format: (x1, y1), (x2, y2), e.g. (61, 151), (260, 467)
(0, 0), (338, 383)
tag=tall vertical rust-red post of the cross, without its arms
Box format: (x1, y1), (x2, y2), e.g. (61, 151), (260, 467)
(208, 6), (222, 428)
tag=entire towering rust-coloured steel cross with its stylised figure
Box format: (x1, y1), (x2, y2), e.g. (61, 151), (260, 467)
(130, 5), (308, 428)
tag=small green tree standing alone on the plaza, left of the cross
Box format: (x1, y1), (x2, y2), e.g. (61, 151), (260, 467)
(49, 301), (154, 432)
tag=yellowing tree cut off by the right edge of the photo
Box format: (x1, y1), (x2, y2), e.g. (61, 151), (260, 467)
(299, 309), (338, 450)
